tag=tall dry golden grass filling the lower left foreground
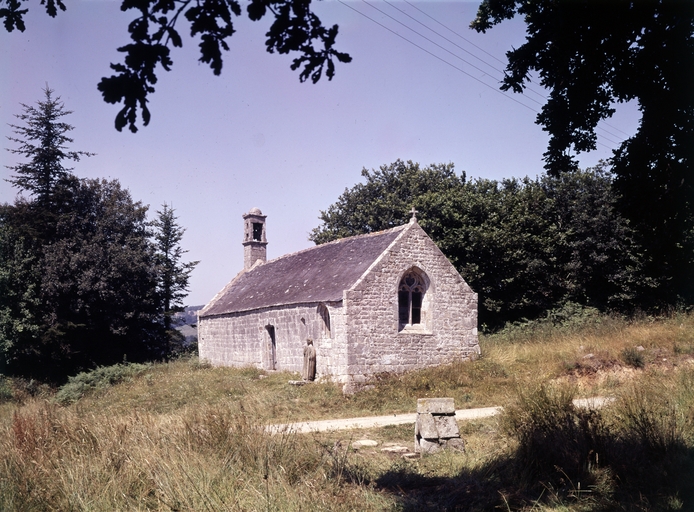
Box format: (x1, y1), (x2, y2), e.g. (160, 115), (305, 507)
(0, 402), (386, 511)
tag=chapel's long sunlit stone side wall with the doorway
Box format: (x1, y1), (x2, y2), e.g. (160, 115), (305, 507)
(198, 302), (347, 380)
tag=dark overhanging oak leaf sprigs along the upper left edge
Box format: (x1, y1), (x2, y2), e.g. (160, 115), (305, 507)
(0, 0), (352, 132)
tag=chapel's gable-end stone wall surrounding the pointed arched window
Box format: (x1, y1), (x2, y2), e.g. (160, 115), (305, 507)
(344, 226), (479, 383)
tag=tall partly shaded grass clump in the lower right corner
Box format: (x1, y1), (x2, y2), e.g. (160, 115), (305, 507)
(503, 369), (694, 510)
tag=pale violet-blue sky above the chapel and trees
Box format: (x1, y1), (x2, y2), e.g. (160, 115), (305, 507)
(0, 0), (639, 305)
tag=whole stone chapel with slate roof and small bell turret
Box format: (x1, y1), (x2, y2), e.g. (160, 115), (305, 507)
(198, 208), (479, 392)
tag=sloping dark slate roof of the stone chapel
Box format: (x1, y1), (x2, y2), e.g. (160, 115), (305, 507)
(200, 225), (407, 316)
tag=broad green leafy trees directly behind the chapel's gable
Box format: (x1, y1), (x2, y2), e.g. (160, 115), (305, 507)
(310, 160), (653, 327)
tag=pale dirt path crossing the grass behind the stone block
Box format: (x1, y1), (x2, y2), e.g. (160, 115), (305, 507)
(266, 397), (614, 434)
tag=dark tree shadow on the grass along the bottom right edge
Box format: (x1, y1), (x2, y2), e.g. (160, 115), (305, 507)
(374, 443), (694, 512)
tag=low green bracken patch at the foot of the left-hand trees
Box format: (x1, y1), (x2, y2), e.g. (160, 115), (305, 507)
(55, 363), (152, 405)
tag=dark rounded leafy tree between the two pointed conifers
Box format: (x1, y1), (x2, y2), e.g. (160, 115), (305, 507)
(41, 180), (168, 372)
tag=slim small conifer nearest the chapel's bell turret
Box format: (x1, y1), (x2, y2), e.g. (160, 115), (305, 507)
(153, 203), (200, 333)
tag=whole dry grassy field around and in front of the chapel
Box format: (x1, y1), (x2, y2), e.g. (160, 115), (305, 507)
(0, 314), (694, 511)
